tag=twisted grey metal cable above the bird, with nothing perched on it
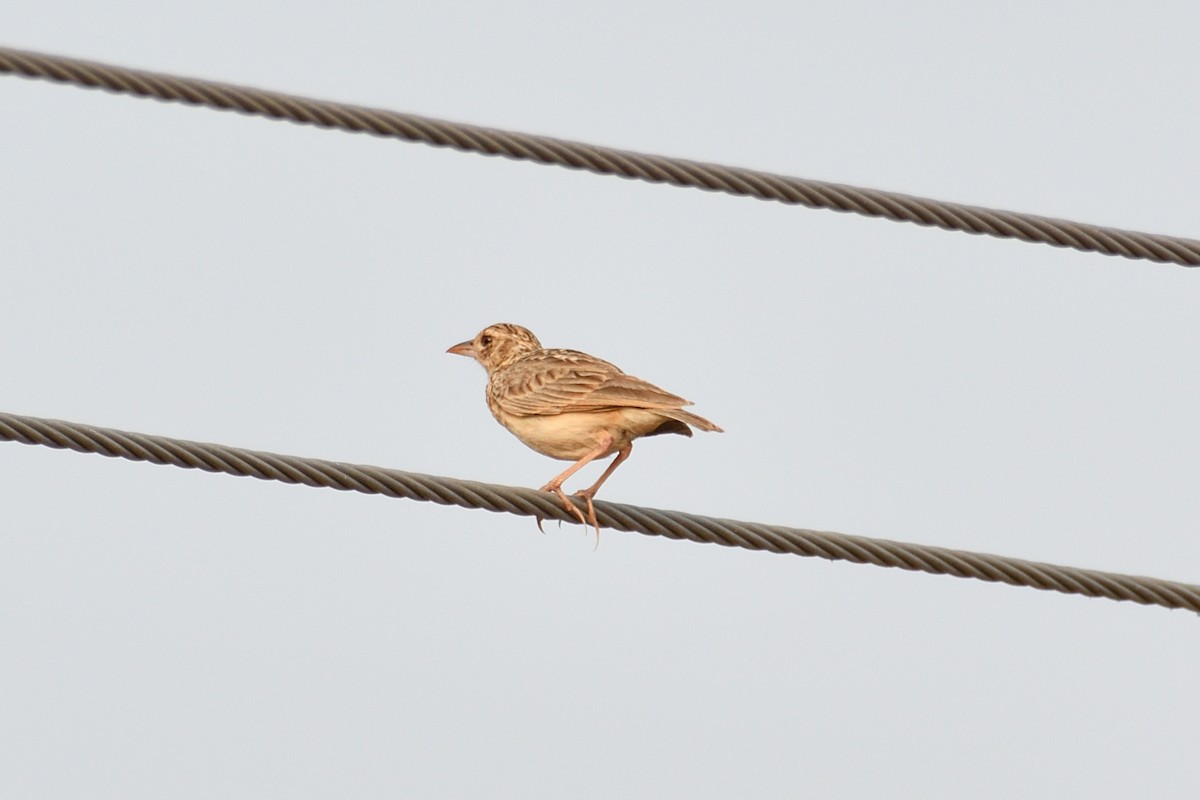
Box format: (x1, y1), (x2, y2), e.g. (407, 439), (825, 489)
(0, 48), (1200, 266)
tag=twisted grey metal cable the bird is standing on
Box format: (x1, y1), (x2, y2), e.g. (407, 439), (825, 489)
(0, 413), (1200, 612)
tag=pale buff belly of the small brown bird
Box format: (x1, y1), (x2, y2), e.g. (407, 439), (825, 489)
(497, 408), (666, 461)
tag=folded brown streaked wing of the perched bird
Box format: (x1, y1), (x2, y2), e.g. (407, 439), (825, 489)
(490, 350), (691, 416)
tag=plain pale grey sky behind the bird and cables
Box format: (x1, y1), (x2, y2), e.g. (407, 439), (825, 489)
(0, 0), (1200, 798)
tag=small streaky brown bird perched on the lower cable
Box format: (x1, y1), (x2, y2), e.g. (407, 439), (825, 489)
(446, 323), (721, 536)
